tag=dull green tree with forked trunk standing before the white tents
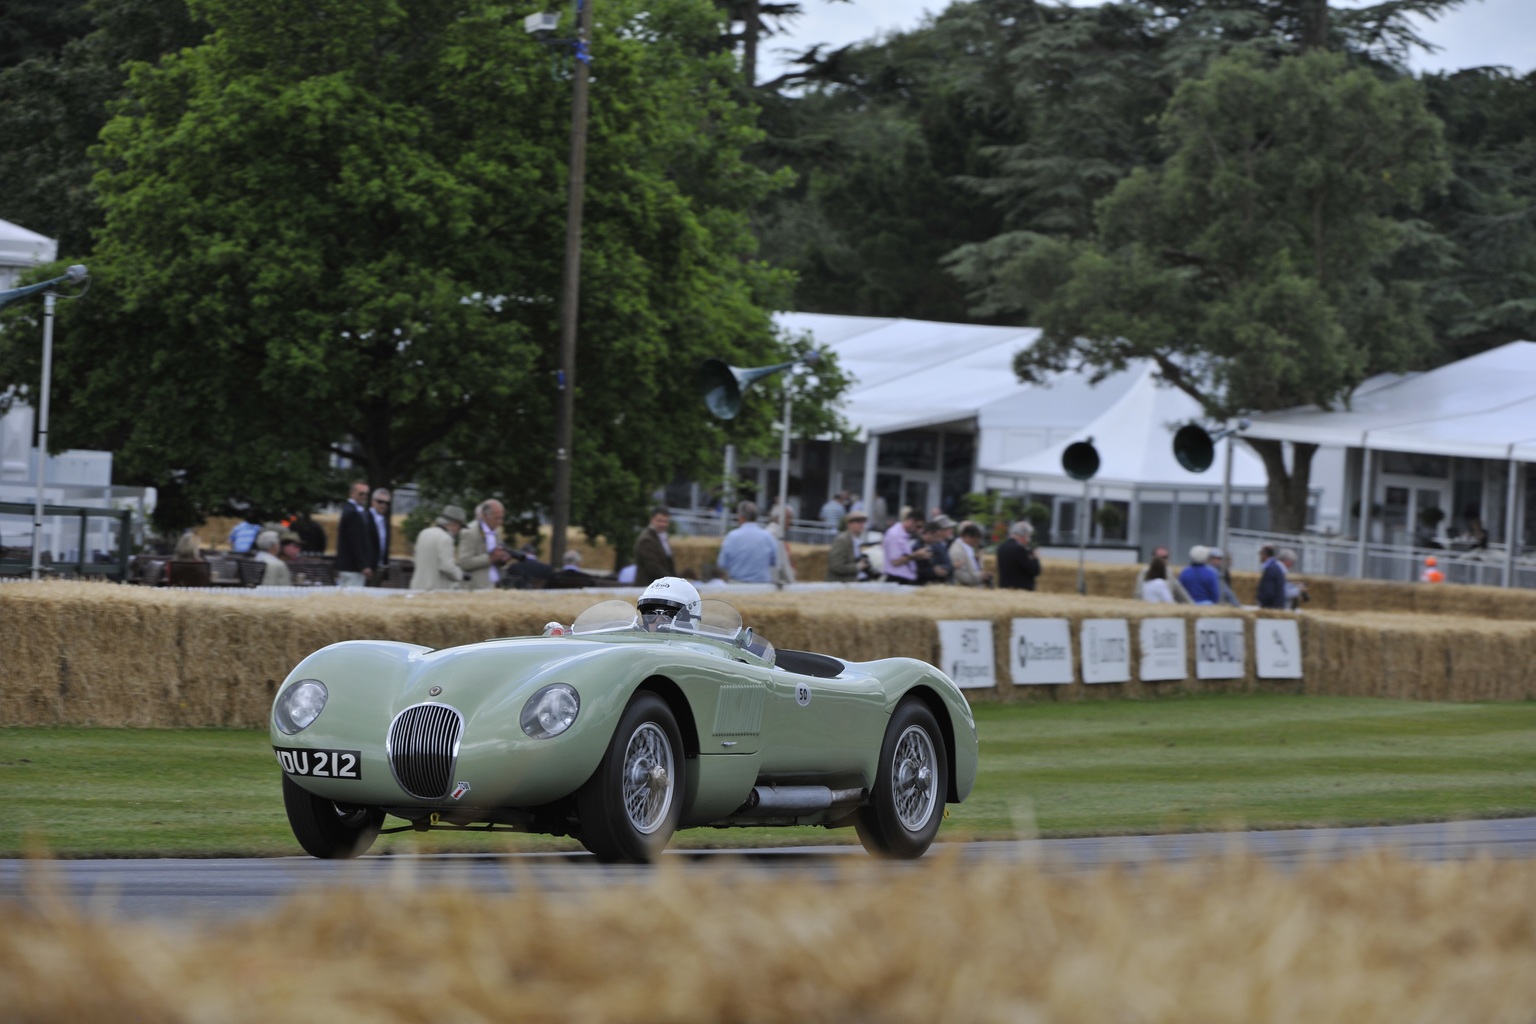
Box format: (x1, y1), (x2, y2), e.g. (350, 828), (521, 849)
(954, 51), (1448, 530)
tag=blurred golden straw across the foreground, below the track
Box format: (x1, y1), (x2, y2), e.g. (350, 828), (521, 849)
(0, 854), (1536, 1024)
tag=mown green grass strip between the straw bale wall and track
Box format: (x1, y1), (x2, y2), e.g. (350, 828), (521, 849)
(0, 695), (1536, 857)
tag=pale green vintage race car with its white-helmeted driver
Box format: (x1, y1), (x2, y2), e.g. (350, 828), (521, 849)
(272, 579), (977, 861)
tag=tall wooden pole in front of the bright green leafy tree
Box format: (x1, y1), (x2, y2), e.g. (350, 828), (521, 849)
(550, 0), (593, 563)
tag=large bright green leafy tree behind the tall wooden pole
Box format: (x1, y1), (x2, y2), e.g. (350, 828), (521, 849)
(0, 0), (829, 543)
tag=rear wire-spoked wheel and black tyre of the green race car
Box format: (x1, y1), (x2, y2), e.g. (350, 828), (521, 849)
(854, 699), (949, 860)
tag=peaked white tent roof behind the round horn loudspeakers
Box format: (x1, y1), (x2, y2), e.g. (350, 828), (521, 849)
(980, 364), (1269, 494)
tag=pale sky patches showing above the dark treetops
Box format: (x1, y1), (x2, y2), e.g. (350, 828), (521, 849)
(760, 0), (1536, 78)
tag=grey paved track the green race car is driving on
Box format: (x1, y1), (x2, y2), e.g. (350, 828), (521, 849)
(0, 818), (1536, 918)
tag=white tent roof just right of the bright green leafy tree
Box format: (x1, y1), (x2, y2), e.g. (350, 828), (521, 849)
(774, 313), (1040, 436)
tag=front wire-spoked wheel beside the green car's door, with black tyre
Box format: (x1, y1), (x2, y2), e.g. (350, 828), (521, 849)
(576, 691), (684, 864)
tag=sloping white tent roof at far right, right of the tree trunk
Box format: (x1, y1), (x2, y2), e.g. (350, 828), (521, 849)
(1244, 341), (1536, 462)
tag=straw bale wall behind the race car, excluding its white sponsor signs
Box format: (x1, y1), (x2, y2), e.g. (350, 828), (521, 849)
(0, 582), (1536, 726)
